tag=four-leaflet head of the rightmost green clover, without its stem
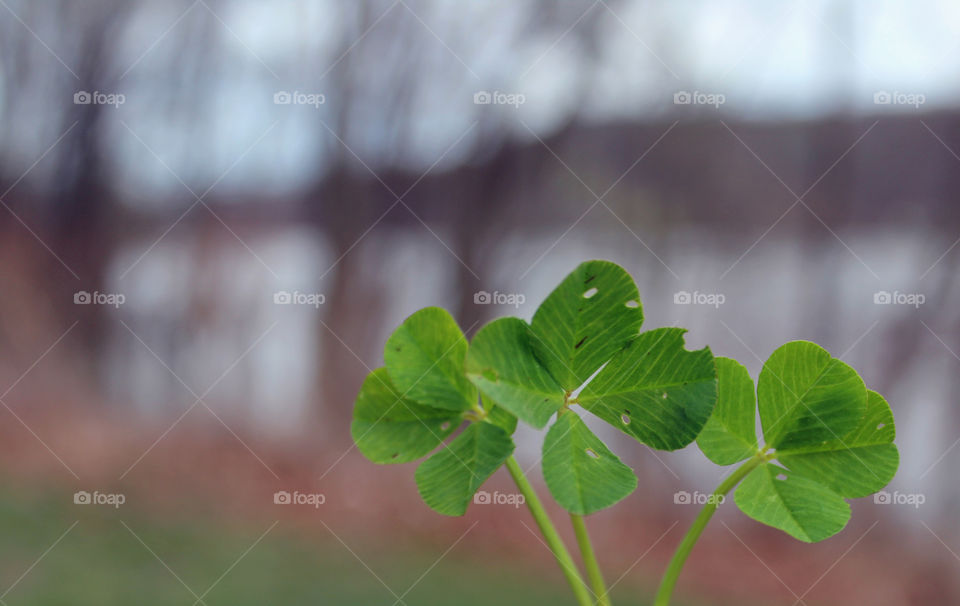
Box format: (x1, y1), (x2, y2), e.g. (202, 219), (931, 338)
(697, 341), (900, 542)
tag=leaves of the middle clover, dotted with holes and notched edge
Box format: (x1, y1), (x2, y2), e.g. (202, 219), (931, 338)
(467, 261), (717, 515)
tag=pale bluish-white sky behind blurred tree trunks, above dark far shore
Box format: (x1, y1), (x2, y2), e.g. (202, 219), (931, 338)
(7, 0), (960, 195)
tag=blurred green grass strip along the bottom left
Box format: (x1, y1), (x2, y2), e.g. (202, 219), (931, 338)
(0, 492), (680, 606)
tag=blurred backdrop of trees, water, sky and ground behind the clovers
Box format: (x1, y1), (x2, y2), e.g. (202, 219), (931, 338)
(0, 0), (960, 606)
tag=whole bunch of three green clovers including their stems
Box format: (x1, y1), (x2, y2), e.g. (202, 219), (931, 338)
(351, 261), (899, 606)
